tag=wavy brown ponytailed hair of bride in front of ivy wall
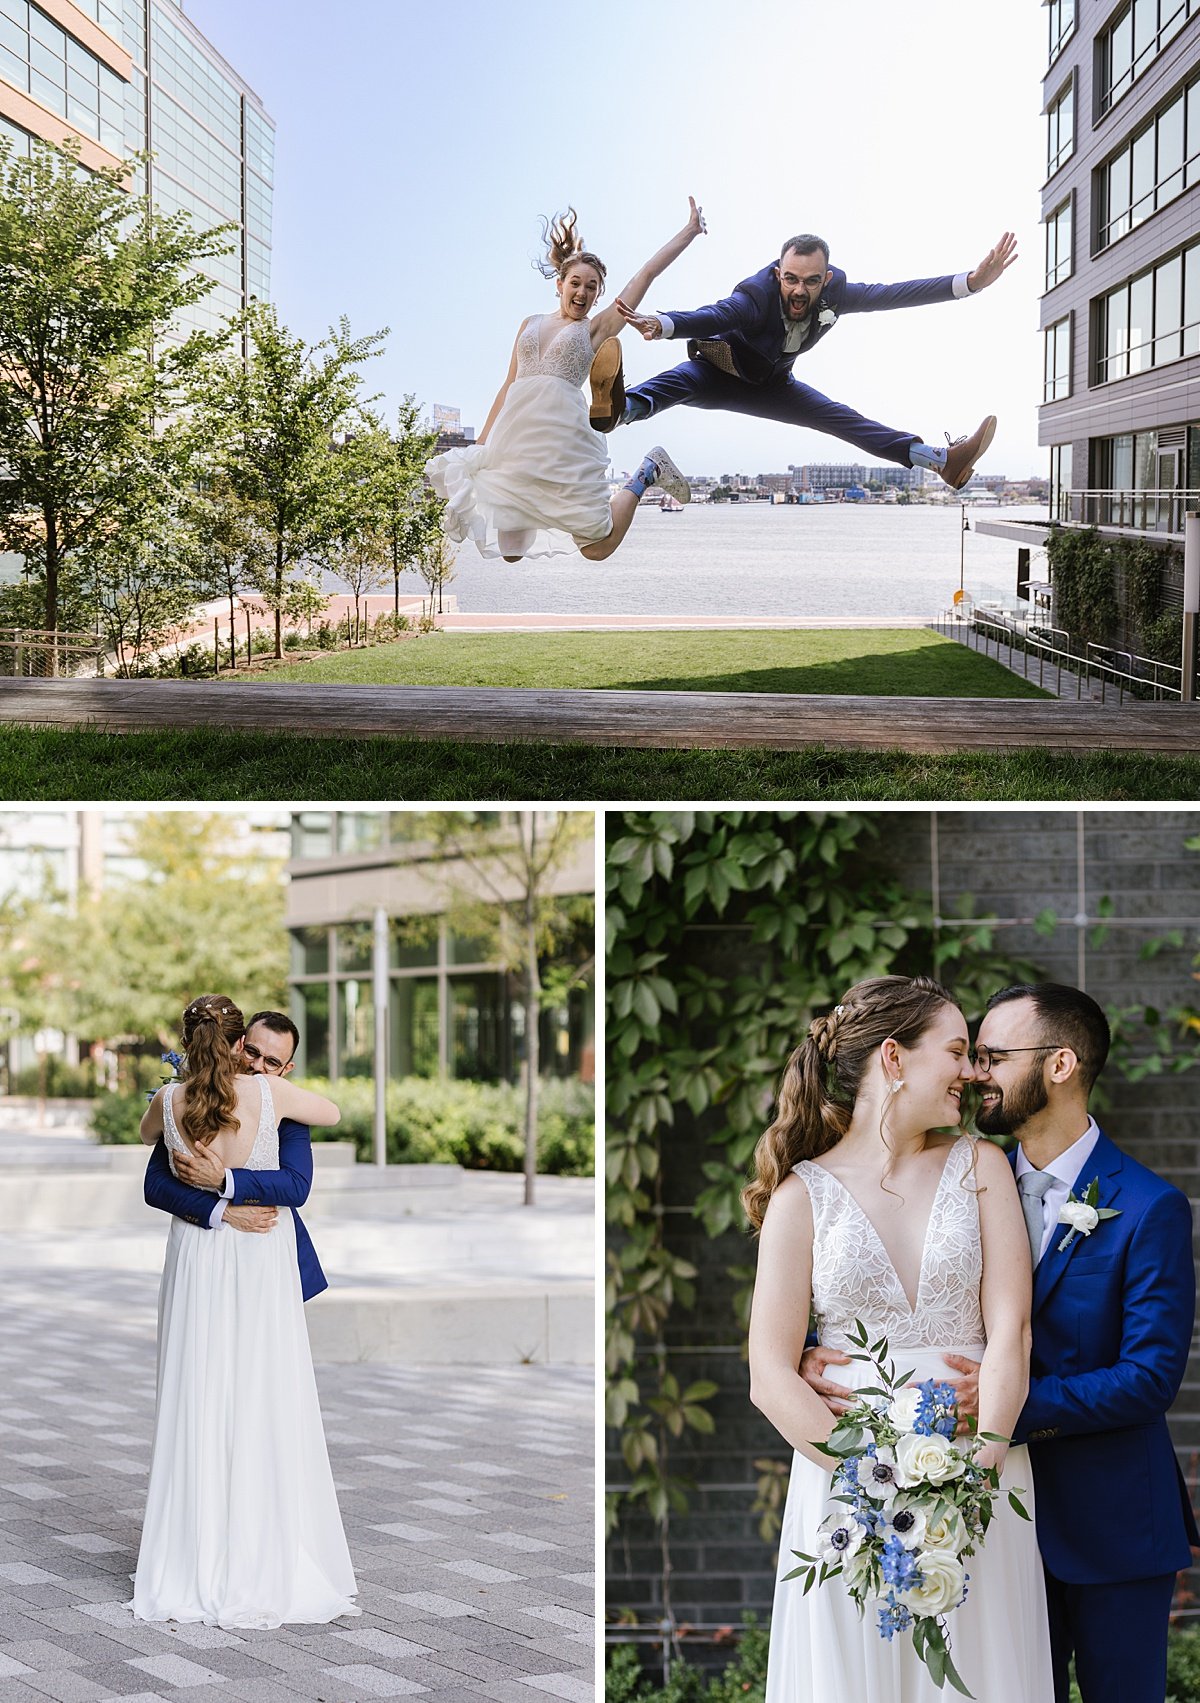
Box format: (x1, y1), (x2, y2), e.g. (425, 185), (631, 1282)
(742, 976), (957, 1230)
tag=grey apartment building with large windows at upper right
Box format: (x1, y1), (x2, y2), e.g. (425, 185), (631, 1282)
(1038, 0), (1200, 545)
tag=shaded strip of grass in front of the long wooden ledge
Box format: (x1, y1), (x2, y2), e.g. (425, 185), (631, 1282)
(0, 727), (1200, 804)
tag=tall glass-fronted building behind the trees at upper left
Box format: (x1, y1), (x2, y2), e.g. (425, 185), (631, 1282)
(0, 0), (274, 329)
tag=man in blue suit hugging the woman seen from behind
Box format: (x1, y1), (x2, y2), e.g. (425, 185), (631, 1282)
(145, 1012), (329, 1301)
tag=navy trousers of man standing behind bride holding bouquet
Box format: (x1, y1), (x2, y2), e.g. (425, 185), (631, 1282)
(1045, 1572), (1174, 1703)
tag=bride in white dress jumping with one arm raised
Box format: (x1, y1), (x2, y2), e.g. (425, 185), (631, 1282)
(426, 196), (705, 562)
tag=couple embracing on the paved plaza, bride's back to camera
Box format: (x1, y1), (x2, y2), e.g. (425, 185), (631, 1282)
(133, 995), (359, 1628)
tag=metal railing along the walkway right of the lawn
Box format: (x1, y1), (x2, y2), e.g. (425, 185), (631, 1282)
(934, 610), (1183, 703)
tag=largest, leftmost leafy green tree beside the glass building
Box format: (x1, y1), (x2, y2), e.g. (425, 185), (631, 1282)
(0, 136), (230, 650)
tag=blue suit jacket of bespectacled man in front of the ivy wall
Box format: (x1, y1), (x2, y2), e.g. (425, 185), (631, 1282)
(1009, 1131), (1200, 1584)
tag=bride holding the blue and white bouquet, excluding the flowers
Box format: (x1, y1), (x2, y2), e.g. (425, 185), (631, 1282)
(744, 976), (1054, 1703)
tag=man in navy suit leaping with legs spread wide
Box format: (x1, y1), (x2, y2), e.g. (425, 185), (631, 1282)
(591, 232), (1016, 490)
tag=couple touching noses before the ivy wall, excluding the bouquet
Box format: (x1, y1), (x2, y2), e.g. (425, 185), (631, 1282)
(744, 976), (1200, 1703)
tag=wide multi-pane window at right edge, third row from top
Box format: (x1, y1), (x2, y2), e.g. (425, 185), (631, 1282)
(1102, 244), (1200, 385)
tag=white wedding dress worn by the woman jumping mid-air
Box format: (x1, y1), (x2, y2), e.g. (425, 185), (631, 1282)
(426, 313), (613, 557)
